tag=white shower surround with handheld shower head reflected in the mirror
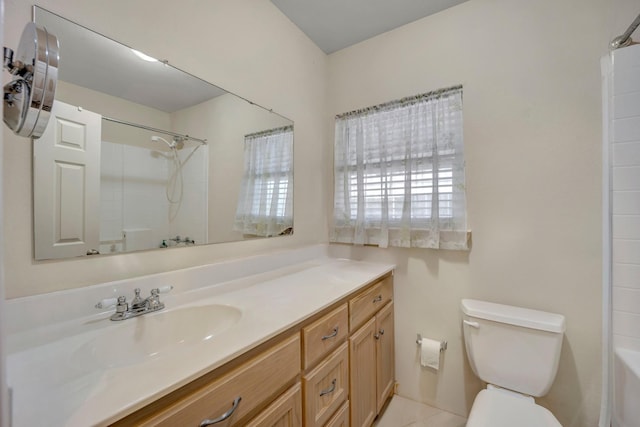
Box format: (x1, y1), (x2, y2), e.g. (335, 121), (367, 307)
(100, 120), (208, 254)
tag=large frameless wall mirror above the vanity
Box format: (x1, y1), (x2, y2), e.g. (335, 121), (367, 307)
(33, 6), (293, 259)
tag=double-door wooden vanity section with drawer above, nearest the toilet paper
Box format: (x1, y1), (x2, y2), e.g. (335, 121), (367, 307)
(349, 290), (395, 427)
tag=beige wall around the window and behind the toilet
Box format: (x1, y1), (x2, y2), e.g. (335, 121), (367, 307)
(327, 0), (640, 427)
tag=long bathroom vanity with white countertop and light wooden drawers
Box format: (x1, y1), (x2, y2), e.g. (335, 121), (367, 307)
(9, 249), (395, 427)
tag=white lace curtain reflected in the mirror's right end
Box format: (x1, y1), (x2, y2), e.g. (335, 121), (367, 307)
(234, 126), (293, 237)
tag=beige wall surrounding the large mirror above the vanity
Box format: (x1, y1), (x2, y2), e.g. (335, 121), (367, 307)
(3, 0), (328, 298)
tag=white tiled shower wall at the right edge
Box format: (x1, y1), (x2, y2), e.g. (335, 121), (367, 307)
(610, 45), (640, 351)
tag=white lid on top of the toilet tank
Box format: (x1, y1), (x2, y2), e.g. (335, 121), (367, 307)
(461, 299), (565, 333)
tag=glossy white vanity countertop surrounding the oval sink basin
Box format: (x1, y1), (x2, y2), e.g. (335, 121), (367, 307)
(7, 259), (394, 427)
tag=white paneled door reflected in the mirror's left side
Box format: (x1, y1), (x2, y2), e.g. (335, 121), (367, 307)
(33, 100), (102, 259)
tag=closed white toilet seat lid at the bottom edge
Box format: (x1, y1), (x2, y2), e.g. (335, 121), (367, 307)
(467, 389), (562, 427)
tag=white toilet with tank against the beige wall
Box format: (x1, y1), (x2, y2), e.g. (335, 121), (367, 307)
(462, 299), (565, 427)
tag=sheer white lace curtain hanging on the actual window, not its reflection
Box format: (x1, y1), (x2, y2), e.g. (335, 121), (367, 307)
(330, 86), (468, 250)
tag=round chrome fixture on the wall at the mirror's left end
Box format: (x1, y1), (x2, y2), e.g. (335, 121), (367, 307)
(3, 22), (60, 138)
